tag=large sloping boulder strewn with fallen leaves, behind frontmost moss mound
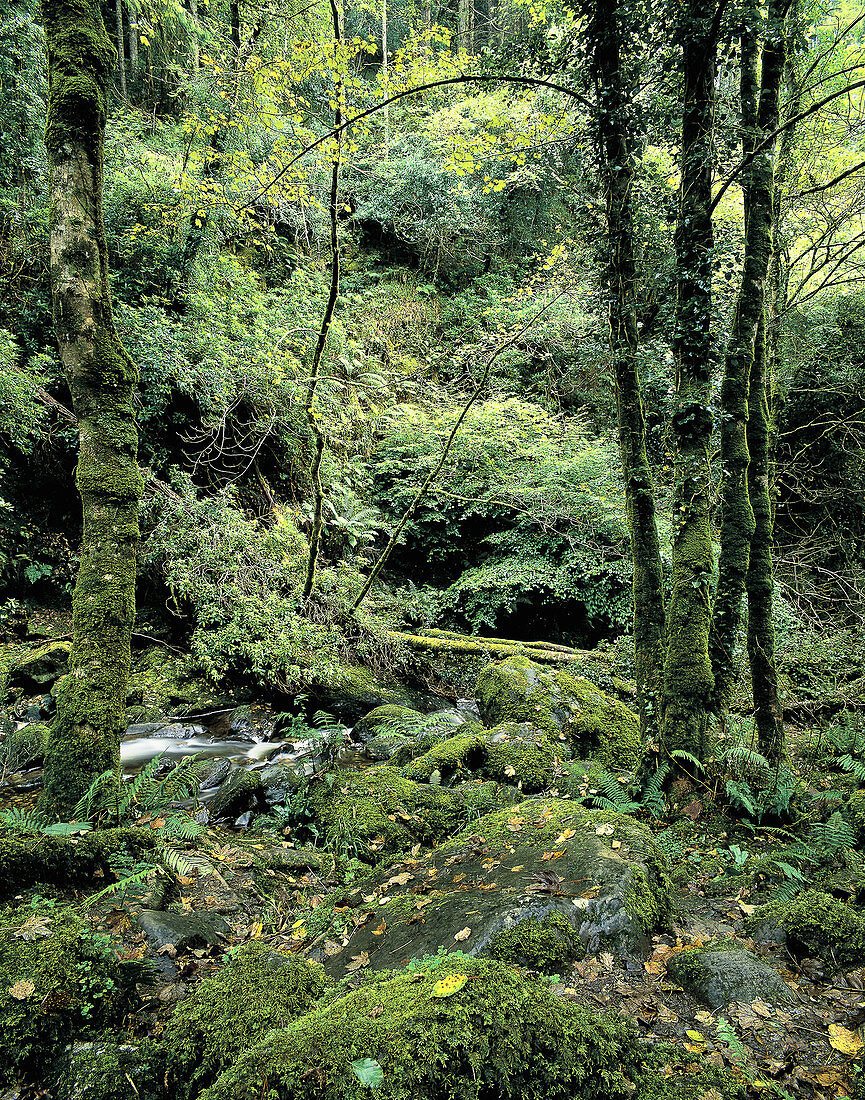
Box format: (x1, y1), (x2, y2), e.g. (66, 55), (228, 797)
(312, 799), (671, 976)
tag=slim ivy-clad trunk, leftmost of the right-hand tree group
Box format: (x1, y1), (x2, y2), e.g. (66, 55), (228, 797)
(589, 0), (664, 741)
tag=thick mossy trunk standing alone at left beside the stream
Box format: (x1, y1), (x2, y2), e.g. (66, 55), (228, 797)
(43, 0), (142, 816)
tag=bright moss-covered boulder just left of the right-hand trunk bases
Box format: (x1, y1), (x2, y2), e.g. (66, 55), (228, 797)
(477, 657), (640, 768)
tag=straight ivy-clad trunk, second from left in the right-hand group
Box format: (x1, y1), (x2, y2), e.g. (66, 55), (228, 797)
(660, 0), (718, 760)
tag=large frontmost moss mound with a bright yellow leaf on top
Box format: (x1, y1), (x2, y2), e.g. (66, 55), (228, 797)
(195, 956), (643, 1100)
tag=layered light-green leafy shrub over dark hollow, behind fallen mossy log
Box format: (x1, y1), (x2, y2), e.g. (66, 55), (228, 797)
(373, 399), (629, 641)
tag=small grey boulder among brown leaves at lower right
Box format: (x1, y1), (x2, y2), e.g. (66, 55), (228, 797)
(667, 947), (792, 1009)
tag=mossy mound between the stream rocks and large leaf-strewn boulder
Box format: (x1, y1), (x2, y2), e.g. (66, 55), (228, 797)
(309, 766), (462, 861)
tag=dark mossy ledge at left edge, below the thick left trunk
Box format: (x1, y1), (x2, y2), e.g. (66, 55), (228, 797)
(0, 828), (156, 902)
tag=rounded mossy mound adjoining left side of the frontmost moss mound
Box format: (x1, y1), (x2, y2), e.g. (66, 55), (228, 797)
(160, 942), (328, 1096)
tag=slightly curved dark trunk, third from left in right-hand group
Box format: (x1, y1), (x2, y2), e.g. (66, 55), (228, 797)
(712, 0), (788, 712)
